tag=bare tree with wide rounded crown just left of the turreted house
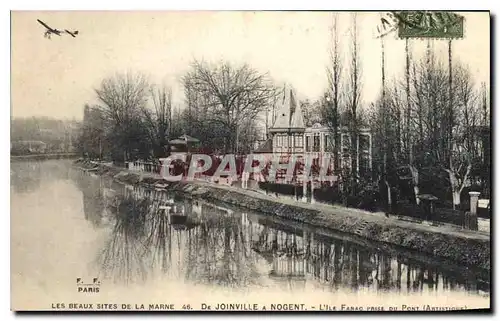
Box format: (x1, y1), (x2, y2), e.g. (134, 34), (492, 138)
(183, 61), (275, 152)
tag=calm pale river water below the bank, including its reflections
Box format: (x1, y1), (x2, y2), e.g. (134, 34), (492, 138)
(11, 160), (490, 310)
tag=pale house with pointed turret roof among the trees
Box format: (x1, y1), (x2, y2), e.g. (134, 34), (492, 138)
(254, 89), (372, 172)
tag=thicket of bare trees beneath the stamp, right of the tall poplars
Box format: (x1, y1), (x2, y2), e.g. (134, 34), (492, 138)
(369, 51), (491, 207)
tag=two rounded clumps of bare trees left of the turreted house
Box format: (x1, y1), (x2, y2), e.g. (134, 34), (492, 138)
(80, 61), (280, 161)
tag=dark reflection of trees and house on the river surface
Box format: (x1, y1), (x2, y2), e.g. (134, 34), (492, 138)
(78, 172), (489, 292)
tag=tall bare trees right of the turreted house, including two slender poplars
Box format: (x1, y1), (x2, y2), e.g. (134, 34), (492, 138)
(318, 14), (491, 208)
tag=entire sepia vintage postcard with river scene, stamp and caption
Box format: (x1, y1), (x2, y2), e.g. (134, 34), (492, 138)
(10, 10), (492, 312)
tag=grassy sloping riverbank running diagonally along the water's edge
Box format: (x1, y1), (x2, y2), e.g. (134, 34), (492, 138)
(75, 160), (490, 270)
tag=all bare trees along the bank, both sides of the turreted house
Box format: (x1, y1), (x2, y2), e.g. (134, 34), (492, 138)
(79, 14), (491, 207)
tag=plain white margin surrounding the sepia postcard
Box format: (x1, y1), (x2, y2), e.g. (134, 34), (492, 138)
(0, 0), (500, 320)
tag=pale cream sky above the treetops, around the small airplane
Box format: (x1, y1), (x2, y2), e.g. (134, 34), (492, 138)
(11, 11), (490, 119)
